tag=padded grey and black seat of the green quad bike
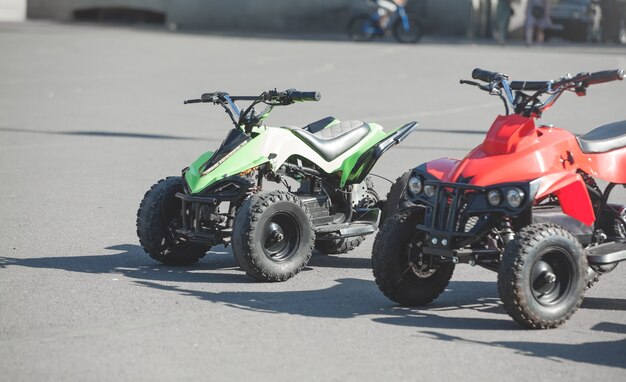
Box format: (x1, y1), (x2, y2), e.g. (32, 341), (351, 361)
(291, 117), (370, 162)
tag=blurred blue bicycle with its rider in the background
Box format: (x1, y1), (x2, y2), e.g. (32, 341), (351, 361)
(348, 0), (424, 43)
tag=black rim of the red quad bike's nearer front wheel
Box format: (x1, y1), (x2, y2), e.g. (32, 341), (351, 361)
(530, 247), (574, 306)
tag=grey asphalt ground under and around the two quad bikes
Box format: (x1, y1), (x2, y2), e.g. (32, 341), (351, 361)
(0, 23), (626, 381)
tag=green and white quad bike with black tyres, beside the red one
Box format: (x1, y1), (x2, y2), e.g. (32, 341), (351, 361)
(137, 89), (417, 281)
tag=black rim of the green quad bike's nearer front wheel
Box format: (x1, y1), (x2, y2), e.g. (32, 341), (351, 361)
(261, 212), (301, 262)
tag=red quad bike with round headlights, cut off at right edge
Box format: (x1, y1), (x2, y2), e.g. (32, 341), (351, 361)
(372, 69), (626, 328)
